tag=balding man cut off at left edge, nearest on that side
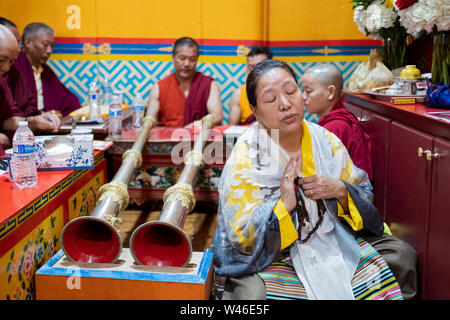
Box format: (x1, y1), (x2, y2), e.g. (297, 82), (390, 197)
(0, 25), (58, 153)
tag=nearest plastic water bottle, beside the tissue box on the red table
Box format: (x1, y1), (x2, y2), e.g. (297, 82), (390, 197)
(12, 121), (37, 189)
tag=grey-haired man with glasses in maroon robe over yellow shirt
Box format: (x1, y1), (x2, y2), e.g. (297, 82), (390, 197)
(14, 22), (80, 116)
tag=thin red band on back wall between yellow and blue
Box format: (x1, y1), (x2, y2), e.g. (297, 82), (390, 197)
(55, 37), (382, 47)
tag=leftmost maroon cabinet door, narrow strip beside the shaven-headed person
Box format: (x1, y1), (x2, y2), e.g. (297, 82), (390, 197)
(360, 110), (390, 218)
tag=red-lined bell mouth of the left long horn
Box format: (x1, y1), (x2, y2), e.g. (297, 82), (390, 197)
(61, 216), (122, 263)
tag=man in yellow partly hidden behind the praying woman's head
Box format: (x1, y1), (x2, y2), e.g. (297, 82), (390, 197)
(228, 46), (273, 126)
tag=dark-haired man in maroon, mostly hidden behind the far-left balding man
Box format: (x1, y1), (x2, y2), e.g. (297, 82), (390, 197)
(0, 17), (61, 132)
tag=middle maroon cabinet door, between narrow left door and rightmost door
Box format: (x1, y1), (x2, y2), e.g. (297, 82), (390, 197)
(386, 121), (433, 284)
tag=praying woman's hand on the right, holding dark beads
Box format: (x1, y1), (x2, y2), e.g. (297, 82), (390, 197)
(299, 175), (347, 200)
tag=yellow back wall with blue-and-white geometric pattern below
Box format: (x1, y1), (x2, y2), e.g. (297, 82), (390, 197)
(0, 0), (381, 124)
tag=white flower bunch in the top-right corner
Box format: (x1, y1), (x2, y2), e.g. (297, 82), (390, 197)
(394, 0), (450, 37)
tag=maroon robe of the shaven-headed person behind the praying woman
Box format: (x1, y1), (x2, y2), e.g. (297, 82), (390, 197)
(319, 95), (373, 181)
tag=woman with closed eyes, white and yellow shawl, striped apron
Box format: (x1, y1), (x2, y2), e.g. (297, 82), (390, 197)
(211, 59), (402, 300)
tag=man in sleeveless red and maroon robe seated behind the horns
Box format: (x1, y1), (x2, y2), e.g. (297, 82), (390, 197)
(147, 37), (222, 127)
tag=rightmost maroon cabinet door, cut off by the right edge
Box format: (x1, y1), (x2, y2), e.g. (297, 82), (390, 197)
(424, 138), (450, 300)
